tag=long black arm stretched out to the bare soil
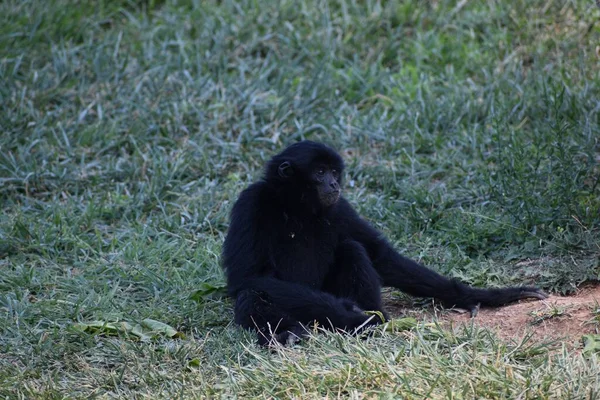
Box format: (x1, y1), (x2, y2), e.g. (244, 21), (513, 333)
(340, 200), (547, 314)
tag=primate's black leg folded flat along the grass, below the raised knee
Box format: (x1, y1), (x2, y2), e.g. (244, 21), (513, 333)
(235, 277), (368, 329)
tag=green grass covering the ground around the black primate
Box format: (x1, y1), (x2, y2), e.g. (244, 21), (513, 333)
(0, 0), (600, 399)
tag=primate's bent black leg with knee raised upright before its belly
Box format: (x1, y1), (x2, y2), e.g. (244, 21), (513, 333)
(324, 240), (387, 319)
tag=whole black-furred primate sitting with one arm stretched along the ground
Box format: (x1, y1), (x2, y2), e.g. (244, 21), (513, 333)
(222, 141), (547, 345)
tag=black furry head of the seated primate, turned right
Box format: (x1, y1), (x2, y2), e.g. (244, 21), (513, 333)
(266, 140), (344, 207)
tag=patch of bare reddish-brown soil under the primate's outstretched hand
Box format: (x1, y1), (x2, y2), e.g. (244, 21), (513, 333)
(385, 283), (600, 347)
